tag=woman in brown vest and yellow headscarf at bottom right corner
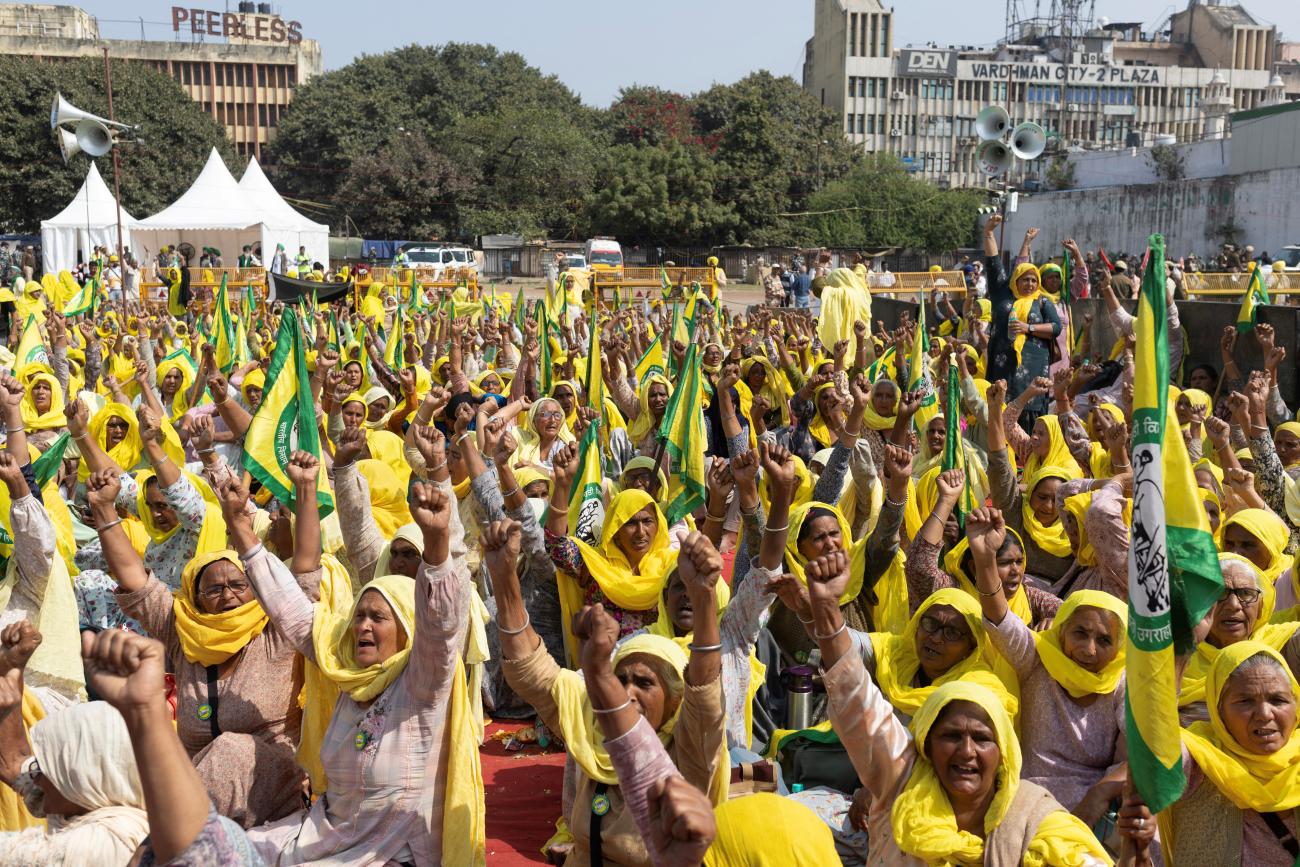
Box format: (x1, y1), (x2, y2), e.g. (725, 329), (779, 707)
(1158, 641), (1300, 864)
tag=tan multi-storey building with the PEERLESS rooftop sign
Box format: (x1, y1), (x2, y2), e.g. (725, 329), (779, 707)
(0, 3), (322, 159)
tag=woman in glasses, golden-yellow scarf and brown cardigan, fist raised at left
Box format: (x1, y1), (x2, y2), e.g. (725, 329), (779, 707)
(90, 472), (320, 828)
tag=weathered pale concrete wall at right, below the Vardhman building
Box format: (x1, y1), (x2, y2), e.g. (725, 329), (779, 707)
(1005, 168), (1300, 257)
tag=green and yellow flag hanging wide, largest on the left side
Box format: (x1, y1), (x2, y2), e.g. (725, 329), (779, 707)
(243, 311), (334, 517)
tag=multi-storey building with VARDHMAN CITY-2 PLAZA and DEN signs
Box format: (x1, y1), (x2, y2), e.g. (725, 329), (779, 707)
(803, 0), (1300, 187)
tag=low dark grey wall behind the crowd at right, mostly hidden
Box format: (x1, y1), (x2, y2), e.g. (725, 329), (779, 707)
(871, 298), (1300, 407)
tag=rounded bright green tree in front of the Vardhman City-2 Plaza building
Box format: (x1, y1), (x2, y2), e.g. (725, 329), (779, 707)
(807, 153), (985, 251)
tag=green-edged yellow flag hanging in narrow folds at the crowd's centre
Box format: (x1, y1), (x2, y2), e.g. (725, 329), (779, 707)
(659, 343), (709, 525)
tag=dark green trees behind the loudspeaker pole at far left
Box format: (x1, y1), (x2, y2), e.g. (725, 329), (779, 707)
(0, 56), (233, 231)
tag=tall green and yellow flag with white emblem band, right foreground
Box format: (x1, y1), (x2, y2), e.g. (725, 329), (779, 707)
(1125, 235), (1223, 812)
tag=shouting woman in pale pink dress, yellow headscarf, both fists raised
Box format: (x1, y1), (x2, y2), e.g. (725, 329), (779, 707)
(240, 467), (486, 867)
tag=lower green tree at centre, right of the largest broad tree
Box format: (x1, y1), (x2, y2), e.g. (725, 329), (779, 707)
(588, 143), (738, 244)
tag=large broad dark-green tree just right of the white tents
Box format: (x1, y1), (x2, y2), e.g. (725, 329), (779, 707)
(269, 43), (598, 237)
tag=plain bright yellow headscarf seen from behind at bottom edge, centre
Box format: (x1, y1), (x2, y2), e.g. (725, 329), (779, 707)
(705, 792), (840, 867)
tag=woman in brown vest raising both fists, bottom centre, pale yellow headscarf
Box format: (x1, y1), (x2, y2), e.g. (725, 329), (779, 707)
(482, 521), (731, 864)
